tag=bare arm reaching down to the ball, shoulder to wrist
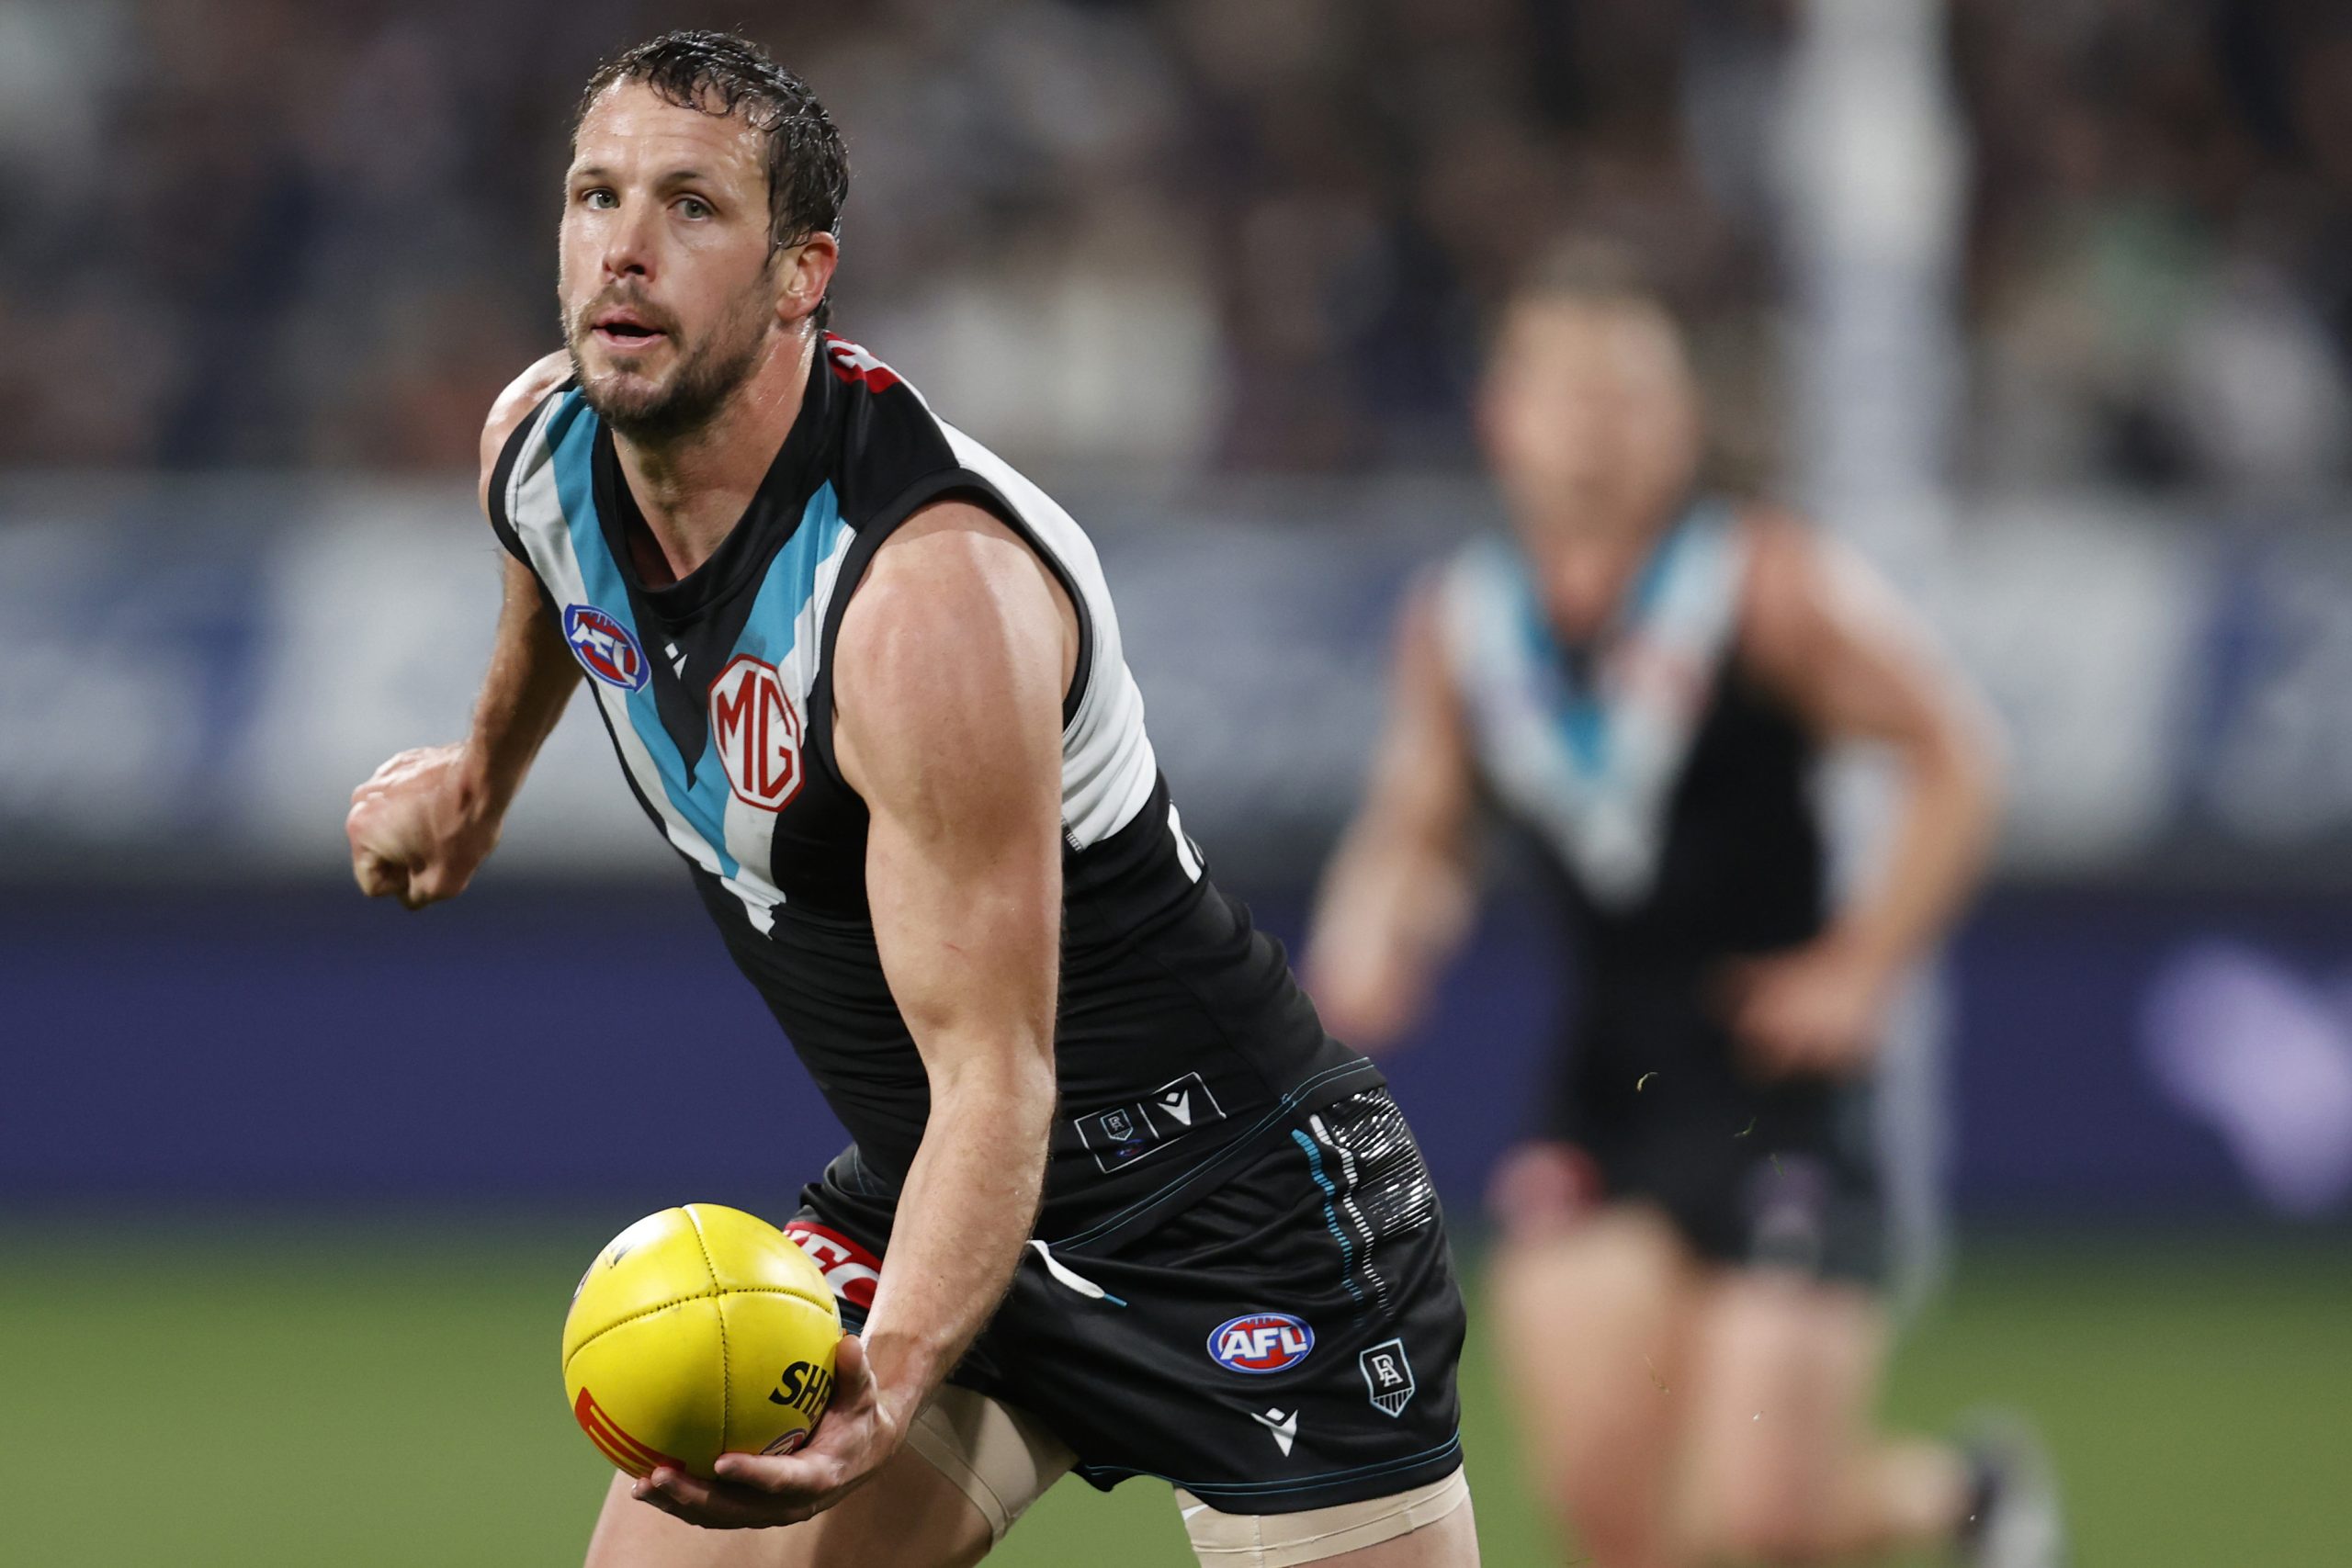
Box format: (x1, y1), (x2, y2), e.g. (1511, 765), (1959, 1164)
(832, 505), (1068, 1425)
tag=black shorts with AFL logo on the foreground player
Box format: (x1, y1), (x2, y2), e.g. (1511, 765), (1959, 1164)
(786, 1089), (1463, 1514)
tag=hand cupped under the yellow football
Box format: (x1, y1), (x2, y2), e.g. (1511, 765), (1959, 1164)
(630, 1336), (906, 1530)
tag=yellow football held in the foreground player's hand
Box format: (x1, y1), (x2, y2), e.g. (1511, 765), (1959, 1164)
(564, 1203), (842, 1476)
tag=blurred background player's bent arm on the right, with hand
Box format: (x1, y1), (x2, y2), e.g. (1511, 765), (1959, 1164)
(1740, 522), (1999, 1065)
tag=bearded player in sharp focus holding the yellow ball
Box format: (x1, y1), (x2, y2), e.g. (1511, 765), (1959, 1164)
(348, 33), (1477, 1568)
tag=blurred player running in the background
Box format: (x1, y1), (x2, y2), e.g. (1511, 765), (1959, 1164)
(1307, 244), (2055, 1568)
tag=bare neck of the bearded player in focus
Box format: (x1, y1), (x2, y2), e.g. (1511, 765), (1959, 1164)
(612, 333), (816, 581)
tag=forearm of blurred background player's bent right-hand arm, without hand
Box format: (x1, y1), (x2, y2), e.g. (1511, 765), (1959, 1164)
(1832, 727), (1999, 971)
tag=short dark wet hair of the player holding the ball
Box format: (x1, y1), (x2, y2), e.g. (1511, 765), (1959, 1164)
(571, 28), (849, 327)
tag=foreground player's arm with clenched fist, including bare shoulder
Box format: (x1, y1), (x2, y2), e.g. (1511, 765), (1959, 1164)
(344, 355), (579, 909)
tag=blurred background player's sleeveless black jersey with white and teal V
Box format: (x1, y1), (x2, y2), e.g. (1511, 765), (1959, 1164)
(1440, 501), (1826, 968)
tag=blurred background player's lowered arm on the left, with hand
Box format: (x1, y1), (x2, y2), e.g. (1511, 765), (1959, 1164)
(1307, 585), (1475, 1048)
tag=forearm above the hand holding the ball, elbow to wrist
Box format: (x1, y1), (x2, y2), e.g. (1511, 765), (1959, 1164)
(865, 1051), (1054, 1420)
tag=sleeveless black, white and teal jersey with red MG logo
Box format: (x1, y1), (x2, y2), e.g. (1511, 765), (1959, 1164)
(489, 333), (1381, 1246)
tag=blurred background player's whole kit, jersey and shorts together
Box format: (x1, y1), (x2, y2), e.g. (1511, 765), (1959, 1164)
(1440, 499), (1884, 1283)
